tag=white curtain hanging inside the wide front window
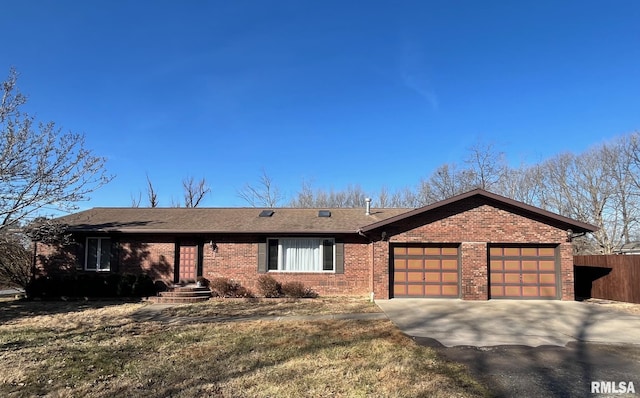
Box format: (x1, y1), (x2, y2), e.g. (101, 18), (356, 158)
(279, 239), (322, 271)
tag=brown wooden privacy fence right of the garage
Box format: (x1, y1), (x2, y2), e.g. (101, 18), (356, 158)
(573, 254), (640, 303)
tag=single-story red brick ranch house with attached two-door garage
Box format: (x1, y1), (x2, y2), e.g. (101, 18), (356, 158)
(36, 189), (596, 300)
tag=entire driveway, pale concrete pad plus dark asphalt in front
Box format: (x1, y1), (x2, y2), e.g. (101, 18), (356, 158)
(378, 299), (640, 397)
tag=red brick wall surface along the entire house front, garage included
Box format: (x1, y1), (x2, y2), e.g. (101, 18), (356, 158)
(38, 198), (574, 300)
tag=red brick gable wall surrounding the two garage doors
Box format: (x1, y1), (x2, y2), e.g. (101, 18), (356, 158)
(375, 198), (574, 300)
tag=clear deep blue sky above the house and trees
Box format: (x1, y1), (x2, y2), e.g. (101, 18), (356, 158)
(0, 0), (640, 208)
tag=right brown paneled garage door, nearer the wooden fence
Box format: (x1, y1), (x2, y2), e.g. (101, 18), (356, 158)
(489, 246), (558, 299)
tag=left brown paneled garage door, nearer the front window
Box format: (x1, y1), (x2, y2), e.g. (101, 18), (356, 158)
(393, 246), (460, 297)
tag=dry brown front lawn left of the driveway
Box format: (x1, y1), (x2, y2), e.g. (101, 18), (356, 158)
(0, 300), (487, 397)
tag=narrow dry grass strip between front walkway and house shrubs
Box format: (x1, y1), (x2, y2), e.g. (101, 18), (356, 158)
(163, 296), (381, 317)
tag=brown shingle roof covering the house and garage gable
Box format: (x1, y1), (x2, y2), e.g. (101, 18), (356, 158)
(58, 189), (598, 234)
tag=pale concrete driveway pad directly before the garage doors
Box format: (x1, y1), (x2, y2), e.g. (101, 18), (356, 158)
(376, 299), (640, 347)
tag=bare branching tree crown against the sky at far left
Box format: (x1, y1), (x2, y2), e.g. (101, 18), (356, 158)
(0, 69), (113, 229)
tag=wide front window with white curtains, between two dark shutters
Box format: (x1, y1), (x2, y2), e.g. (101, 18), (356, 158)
(267, 238), (335, 272)
